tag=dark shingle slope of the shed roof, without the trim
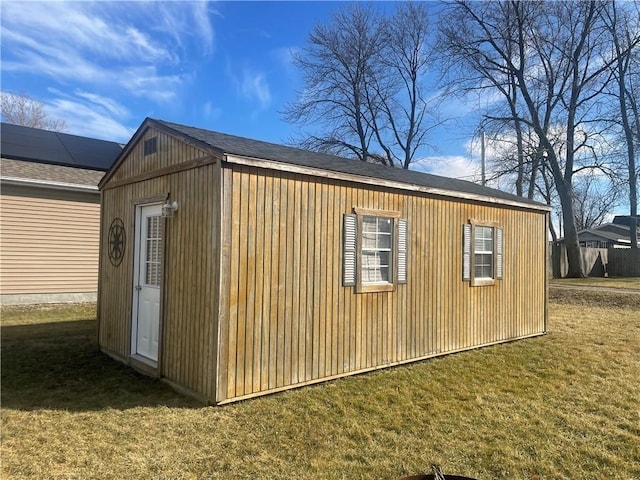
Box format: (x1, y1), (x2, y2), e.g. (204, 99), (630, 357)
(150, 119), (544, 207)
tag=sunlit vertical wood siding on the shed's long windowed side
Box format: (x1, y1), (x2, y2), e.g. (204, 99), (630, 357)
(218, 166), (546, 402)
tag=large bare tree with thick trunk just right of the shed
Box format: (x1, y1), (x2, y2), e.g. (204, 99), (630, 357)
(441, 0), (613, 277)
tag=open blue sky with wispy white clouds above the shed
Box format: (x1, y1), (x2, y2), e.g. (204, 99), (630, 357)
(0, 0), (479, 178)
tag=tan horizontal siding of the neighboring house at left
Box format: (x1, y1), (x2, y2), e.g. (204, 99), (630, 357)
(0, 186), (100, 295)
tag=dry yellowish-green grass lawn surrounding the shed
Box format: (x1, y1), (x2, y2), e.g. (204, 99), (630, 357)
(0, 289), (640, 480)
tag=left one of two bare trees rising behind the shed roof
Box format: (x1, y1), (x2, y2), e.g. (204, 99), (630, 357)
(284, 4), (382, 161)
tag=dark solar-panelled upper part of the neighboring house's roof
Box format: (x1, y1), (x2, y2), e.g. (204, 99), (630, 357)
(0, 123), (122, 172)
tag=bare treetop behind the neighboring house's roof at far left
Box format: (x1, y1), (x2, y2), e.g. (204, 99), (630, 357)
(0, 92), (67, 132)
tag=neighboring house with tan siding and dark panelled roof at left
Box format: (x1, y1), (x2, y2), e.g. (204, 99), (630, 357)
(0, 123), (122, 304)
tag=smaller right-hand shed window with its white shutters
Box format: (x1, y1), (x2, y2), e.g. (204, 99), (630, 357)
(462, 223), (503, 286)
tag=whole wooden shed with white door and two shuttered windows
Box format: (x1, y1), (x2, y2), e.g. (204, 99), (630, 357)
(98, 119), (549, 404)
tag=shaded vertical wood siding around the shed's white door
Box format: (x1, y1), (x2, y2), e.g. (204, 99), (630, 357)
(98, 130), (220, 398)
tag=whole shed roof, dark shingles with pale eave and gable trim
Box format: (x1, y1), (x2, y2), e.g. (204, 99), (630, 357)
(101, 118), (550, 211)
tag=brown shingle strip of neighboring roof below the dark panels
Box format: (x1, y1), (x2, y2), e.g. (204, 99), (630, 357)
(0, 158), (104, 191)
